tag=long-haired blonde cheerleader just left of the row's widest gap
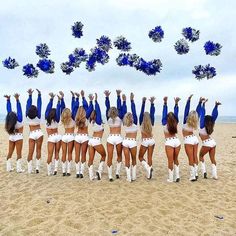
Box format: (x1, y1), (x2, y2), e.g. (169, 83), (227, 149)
(139, 97), (155, 179)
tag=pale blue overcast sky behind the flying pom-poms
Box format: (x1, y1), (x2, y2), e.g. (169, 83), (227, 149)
(0, 0), (236, 115)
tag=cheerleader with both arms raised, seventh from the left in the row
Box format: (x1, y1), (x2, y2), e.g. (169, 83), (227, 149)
(104, 90), (127, 181)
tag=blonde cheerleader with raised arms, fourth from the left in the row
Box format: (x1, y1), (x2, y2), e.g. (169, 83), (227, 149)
(61, 91), (79, 176)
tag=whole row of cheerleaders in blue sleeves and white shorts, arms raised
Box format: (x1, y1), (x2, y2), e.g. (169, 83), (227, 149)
(4, 89), (221, 182)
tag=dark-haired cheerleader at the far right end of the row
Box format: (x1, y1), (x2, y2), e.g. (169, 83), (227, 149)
(199, 99), (221, 179)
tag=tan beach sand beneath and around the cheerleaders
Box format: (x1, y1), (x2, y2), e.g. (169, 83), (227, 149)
(0, 124), (236, 235)
